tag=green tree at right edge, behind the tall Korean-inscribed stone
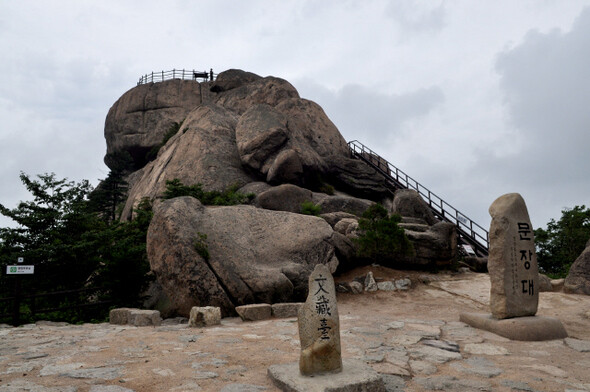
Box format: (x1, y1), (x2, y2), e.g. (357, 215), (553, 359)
(535, 205), (590, 278)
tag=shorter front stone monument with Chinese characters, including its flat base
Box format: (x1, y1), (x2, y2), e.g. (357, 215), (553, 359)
(268, 264), (385, 392)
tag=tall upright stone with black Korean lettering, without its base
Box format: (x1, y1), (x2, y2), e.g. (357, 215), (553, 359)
(488, 193), (539, 319)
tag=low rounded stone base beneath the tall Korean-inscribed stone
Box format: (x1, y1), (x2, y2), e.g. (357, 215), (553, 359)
(459, 313), (567, 341)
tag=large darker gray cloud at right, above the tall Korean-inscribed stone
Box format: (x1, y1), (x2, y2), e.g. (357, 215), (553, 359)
(476, 8), (590, 226)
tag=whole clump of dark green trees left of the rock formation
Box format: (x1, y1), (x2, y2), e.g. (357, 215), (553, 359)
(0, 173), (152, 321)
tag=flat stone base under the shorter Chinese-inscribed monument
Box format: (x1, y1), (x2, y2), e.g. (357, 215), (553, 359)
(268, 359), (386, 392)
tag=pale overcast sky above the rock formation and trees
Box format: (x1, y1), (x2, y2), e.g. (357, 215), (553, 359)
(0, 0), (590, 228)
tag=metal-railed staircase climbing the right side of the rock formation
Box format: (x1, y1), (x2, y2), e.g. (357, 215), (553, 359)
(348, 140), (490, 256)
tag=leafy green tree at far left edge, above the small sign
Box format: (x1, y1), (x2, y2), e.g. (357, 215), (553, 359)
(0, 173), (96, 290)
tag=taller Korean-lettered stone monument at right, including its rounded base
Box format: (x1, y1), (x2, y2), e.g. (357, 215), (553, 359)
(460, 193), (567, 340)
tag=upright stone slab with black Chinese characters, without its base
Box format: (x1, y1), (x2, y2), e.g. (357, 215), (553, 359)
(298, 264), (342, 376)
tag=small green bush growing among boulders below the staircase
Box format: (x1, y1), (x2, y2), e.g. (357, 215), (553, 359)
(355, 204), (414, 265)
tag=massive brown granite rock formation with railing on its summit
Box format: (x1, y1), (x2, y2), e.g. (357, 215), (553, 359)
(105, 69), (456, 316)
